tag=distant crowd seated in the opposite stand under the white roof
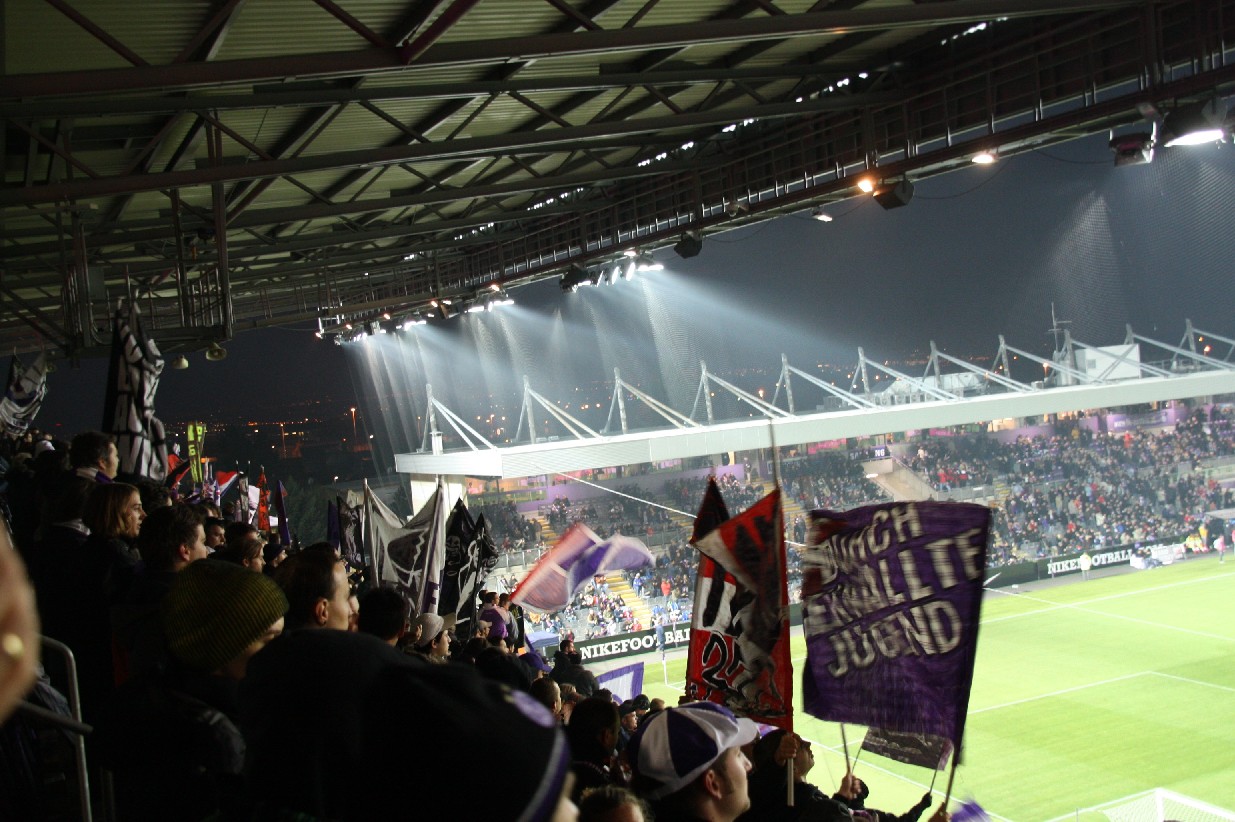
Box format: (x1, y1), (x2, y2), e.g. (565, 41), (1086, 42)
(486, 411), (1235, 638)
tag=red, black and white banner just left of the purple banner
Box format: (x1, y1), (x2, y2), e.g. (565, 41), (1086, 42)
(687, 481), (793, 729)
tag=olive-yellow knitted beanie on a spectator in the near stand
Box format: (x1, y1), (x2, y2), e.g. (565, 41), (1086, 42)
(163, 560), (288, 671)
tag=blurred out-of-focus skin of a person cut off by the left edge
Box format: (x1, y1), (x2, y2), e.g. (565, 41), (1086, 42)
(0, 522), (38, 722)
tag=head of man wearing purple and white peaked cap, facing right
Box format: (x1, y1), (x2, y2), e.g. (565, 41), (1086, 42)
(626, 702), (758, 822)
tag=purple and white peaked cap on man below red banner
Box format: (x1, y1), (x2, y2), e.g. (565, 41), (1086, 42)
(627, 702), (760, 800)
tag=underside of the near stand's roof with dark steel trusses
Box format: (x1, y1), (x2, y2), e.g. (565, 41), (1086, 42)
(0, 0), (1235, 357)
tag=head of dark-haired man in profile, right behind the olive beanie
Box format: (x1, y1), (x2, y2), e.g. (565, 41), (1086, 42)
(274, 546), (352, 631)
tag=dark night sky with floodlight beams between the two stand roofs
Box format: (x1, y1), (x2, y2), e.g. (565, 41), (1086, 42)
(37, 132), (1235, 439)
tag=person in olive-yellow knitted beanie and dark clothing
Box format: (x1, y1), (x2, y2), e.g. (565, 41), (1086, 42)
(98, 552), (288, 821)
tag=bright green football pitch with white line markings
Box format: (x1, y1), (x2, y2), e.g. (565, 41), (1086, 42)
(617, 557), (1235, 822)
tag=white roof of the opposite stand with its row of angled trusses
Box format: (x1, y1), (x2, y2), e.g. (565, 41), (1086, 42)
(395, 321), (1235, 476)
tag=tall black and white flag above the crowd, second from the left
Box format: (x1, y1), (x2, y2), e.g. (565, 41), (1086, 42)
(103, 307), (167, 483)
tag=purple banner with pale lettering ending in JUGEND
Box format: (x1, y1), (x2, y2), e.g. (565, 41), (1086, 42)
(803, 502), (990, 759)
